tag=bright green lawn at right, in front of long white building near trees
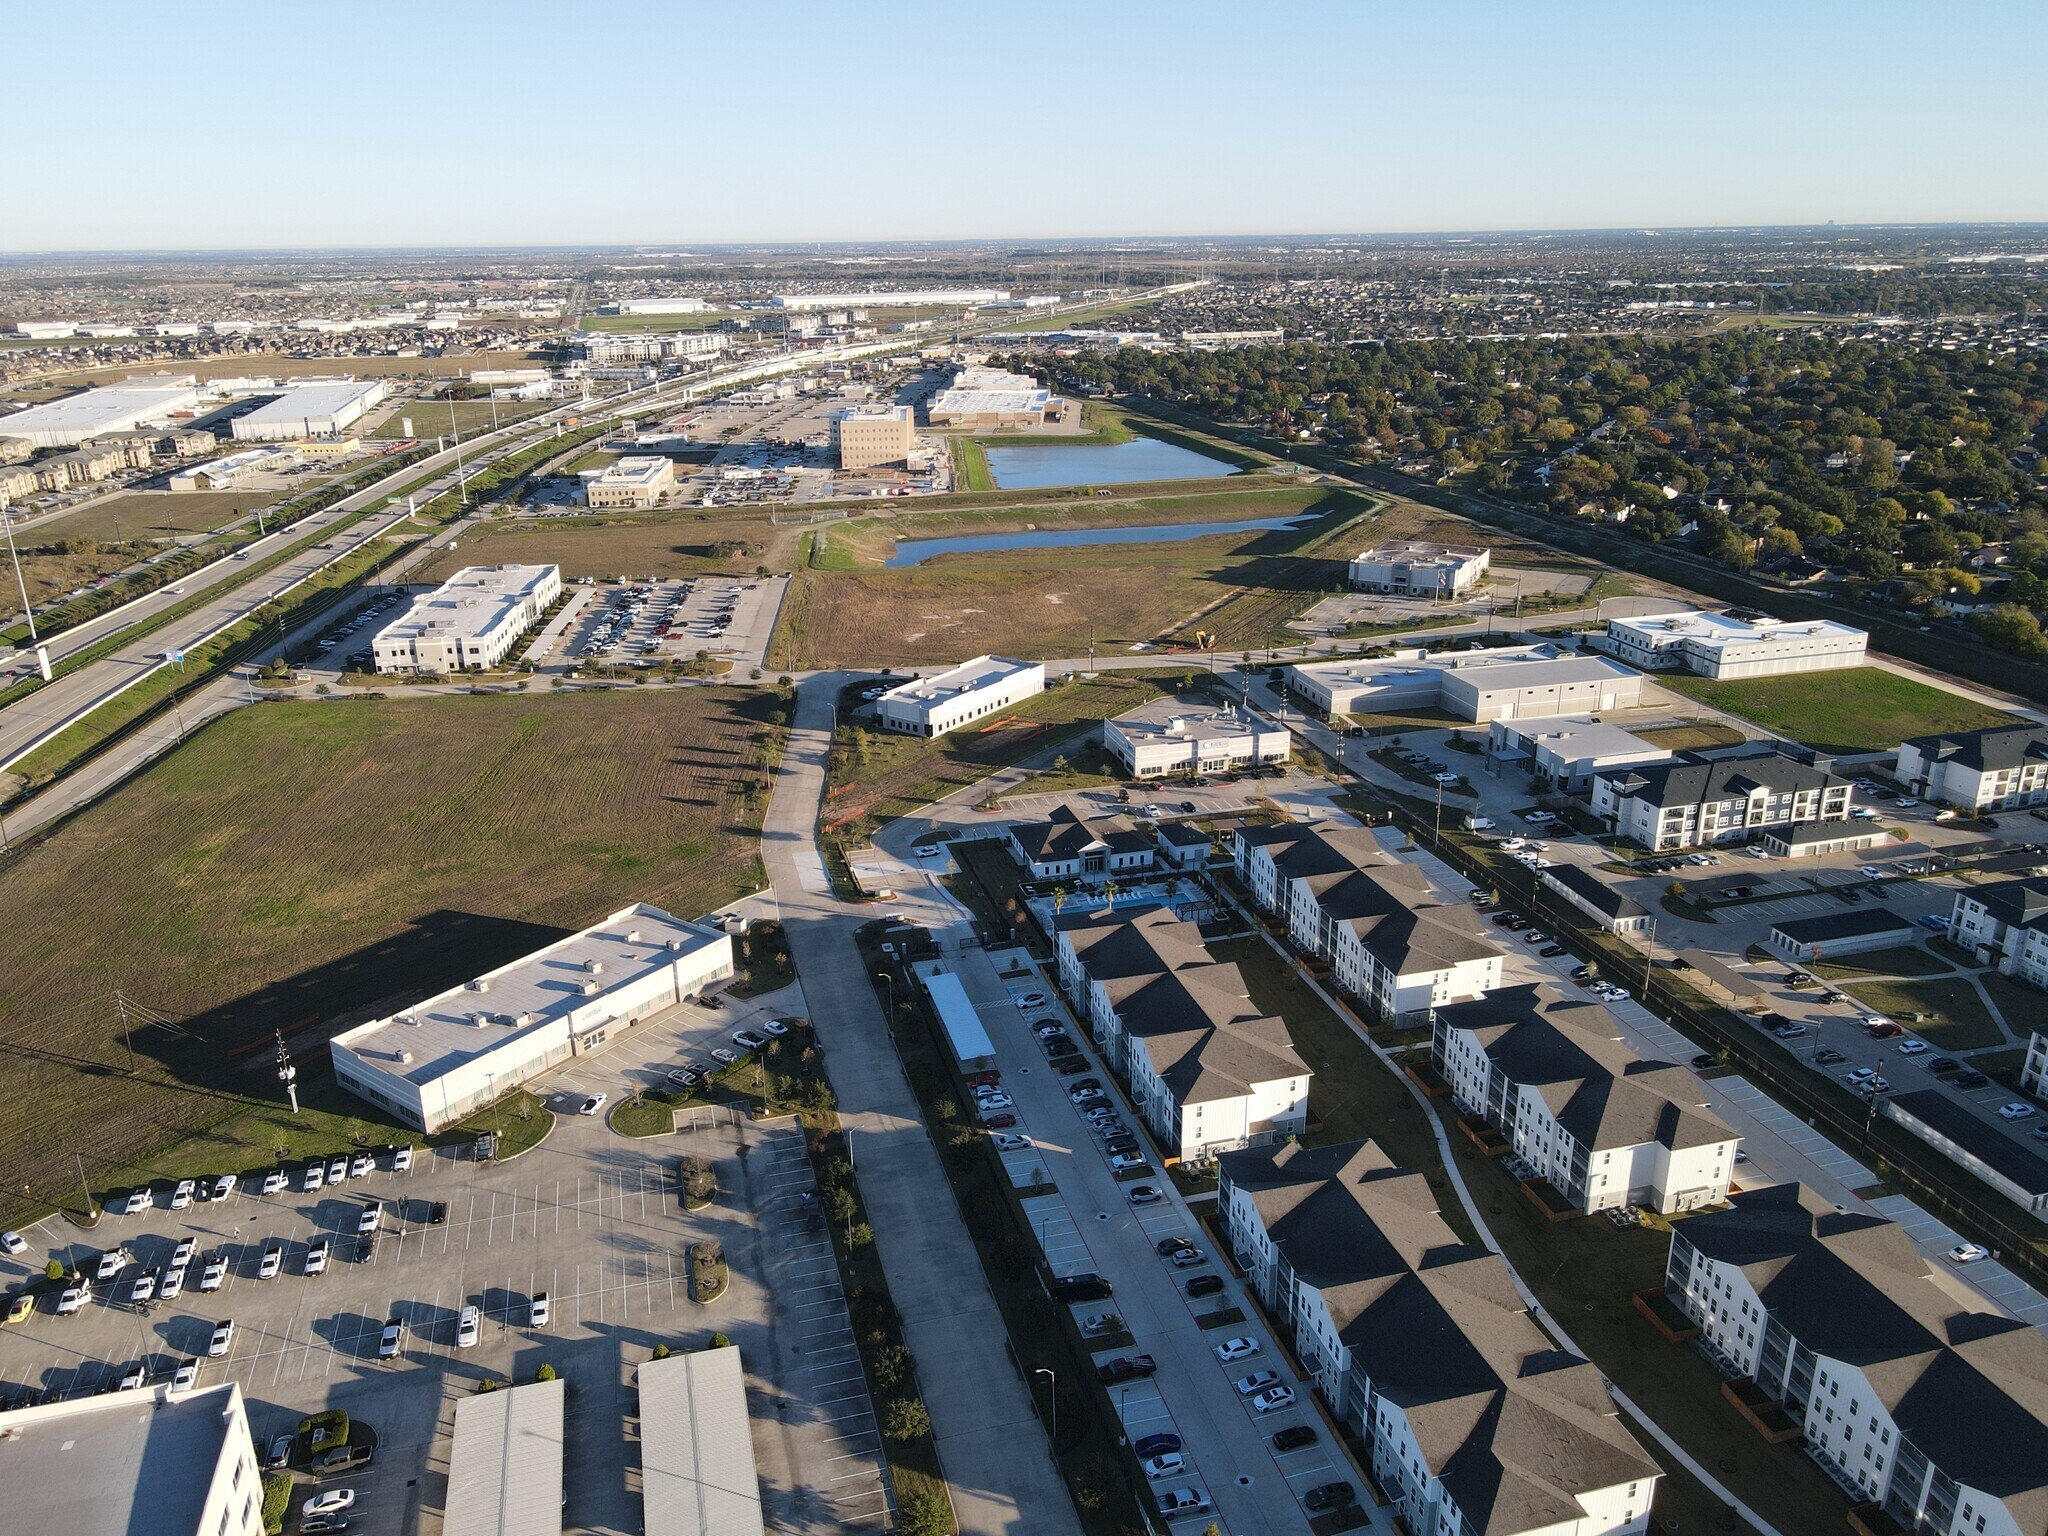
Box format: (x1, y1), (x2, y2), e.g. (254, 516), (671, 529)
(1657, 668), (2013, 752)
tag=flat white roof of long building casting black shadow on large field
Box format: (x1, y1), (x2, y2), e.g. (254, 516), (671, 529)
(334, 903), (727, 1085)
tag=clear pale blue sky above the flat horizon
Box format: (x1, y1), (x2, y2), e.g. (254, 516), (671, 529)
(16, 0), (2048, 250)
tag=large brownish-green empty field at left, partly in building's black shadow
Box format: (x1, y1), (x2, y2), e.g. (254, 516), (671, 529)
(0, 688), (774, 1228)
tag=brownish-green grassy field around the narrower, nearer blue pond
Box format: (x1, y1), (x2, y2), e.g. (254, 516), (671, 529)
(784, 485), (1370, 666)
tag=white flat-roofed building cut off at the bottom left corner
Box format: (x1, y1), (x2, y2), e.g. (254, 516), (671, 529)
(0, 1384), (264, 1536)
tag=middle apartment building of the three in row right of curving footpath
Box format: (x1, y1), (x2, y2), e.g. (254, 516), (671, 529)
(1430, 985), (1739, 1214)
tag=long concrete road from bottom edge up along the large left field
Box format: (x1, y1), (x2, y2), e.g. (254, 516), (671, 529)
(762, 674), (1081, 1536)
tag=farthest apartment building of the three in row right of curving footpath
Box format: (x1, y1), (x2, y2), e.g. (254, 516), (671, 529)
(1235, 825), (1505, 1020)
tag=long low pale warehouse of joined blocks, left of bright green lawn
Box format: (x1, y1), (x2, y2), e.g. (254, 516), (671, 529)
(1286, 645), (1645, 721)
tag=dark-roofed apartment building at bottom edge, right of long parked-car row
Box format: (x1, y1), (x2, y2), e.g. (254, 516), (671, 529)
(1217, 1141), (1659, 1536)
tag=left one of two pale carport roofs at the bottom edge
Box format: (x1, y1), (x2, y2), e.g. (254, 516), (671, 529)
(440, 1376), (569, 1536)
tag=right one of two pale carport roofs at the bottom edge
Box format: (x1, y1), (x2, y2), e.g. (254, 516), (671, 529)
(639, 1346), (762, 1536)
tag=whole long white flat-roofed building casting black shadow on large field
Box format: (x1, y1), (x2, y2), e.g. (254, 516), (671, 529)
(328, 903), (733, 1133)
